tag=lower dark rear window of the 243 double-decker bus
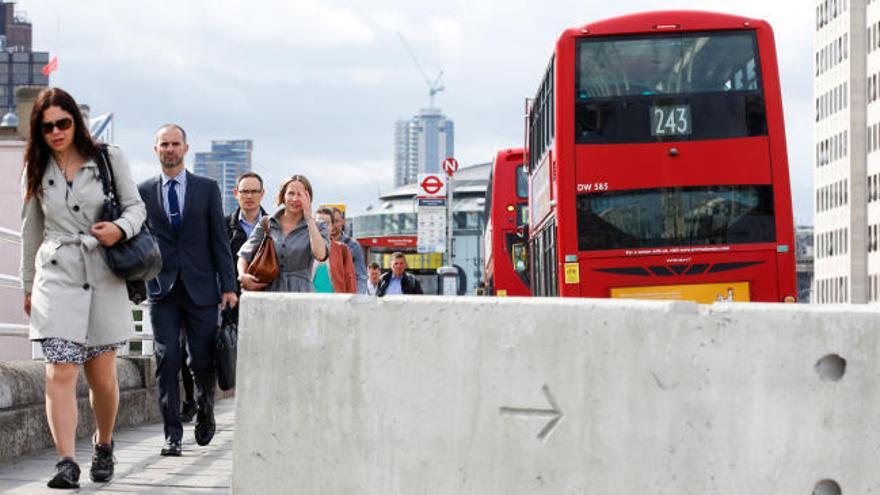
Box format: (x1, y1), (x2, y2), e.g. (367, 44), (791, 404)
(577, 185), (776, 251)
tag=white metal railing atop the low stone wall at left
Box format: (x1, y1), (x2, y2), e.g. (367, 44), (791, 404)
(0, 227), (153, 359)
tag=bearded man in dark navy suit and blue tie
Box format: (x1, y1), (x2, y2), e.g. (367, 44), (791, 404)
(138, 124), (238, 456)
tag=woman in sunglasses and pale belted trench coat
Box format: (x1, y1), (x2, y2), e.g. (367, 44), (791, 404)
(21, 88), (146, 488)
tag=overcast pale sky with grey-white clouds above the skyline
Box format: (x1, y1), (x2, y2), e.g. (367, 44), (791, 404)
(18, 0), (814, 223)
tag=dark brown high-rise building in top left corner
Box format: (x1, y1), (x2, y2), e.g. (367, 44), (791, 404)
(0, 0), (49, 114)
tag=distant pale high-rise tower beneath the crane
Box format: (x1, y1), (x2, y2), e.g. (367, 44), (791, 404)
(394, 108), (455, 187)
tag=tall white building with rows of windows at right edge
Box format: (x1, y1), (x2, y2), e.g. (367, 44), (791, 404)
(812, 0), (868, 303)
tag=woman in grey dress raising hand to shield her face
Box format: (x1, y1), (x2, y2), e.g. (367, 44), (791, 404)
(238, 175), (330, 292)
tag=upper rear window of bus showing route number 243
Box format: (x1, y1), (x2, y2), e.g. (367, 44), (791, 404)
(575, 31), (767, 144)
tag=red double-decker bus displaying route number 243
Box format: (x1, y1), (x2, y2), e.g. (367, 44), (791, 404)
(526, 11), (797, 303)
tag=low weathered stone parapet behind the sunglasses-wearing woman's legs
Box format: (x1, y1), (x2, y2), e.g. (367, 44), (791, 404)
(0, 356), (161, 461)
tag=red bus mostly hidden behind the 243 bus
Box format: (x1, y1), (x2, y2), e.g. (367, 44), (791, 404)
(483, 148), (531, 296)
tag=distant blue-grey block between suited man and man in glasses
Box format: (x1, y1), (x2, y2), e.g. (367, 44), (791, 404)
(193, 139), (254, 215)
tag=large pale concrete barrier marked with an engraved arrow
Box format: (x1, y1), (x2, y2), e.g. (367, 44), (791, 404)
(233, 294), (880, 495)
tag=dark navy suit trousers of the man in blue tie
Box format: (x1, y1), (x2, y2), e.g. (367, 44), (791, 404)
(150, 280), (219, 441)
